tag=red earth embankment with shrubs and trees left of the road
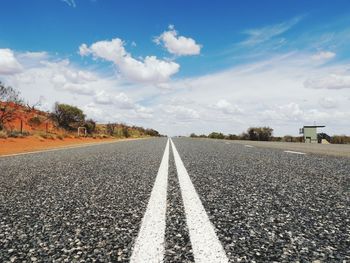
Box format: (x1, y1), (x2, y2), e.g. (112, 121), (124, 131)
(0, 82), (161, 140)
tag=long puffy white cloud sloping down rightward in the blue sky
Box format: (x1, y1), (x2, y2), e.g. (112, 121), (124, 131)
(79, 38), (180, 84)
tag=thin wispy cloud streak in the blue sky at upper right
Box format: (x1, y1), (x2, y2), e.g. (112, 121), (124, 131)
(241, 17), (302, 46)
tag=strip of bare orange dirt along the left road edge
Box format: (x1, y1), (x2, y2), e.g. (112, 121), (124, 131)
(0, 136), (120, 156)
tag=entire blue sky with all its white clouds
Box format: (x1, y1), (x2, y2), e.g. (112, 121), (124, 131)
(0, 0), (350, 135)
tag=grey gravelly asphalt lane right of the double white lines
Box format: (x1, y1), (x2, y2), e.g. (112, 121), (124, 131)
(174, 138), (350, 262)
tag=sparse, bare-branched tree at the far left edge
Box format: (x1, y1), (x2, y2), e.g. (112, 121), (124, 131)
(0, 82), (23, 130)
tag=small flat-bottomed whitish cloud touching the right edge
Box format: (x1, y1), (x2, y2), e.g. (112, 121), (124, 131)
(304, 74), (350, 90)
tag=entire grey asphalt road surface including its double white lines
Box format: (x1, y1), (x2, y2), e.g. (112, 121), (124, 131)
(0, 138), (350, 263)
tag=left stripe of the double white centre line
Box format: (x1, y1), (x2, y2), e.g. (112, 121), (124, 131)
(130, 140), (169, 263)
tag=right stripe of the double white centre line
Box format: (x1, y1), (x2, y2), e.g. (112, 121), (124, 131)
(170, 139), (228, 263)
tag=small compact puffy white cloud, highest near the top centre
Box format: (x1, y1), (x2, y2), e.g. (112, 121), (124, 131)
(155, 25), (201, 56)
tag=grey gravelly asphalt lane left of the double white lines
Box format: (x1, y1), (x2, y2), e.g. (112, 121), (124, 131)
(0, 139), (166, 262)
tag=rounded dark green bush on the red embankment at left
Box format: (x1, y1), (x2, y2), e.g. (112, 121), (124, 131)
(51, 102), (85, 130)
